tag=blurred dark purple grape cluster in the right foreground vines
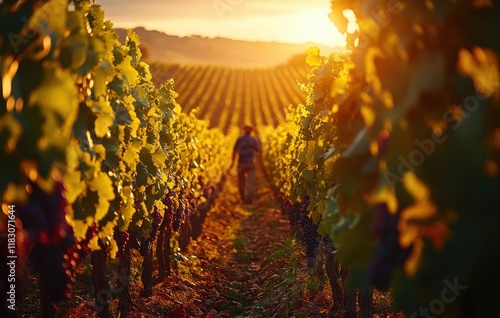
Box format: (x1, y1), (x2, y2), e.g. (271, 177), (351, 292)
(368, 204), (411, 289)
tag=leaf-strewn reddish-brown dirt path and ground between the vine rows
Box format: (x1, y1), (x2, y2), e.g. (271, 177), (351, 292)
(22, 163), (400, 318)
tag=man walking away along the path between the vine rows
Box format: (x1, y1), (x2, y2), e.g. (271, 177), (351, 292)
(229, 125), (261, 204)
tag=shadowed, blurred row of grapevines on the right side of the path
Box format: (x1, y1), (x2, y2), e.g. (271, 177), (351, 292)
(261, 0), (500, 317)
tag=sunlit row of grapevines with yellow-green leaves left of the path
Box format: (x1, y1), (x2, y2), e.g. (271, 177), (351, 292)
(0, 0), (230, 317)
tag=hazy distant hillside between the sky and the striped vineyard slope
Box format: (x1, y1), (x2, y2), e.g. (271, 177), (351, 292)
(116, 27), (344, 67)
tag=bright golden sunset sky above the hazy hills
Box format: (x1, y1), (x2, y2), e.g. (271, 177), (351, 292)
(96, 0), (345, 46)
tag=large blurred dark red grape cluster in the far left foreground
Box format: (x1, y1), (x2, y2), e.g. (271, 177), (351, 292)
(17, 182), (79, 302)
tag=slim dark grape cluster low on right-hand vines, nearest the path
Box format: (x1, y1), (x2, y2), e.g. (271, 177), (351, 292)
(299, 194), (321, 261)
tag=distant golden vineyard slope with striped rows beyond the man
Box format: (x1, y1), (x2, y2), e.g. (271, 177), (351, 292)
(151, 62), (308, 132)
